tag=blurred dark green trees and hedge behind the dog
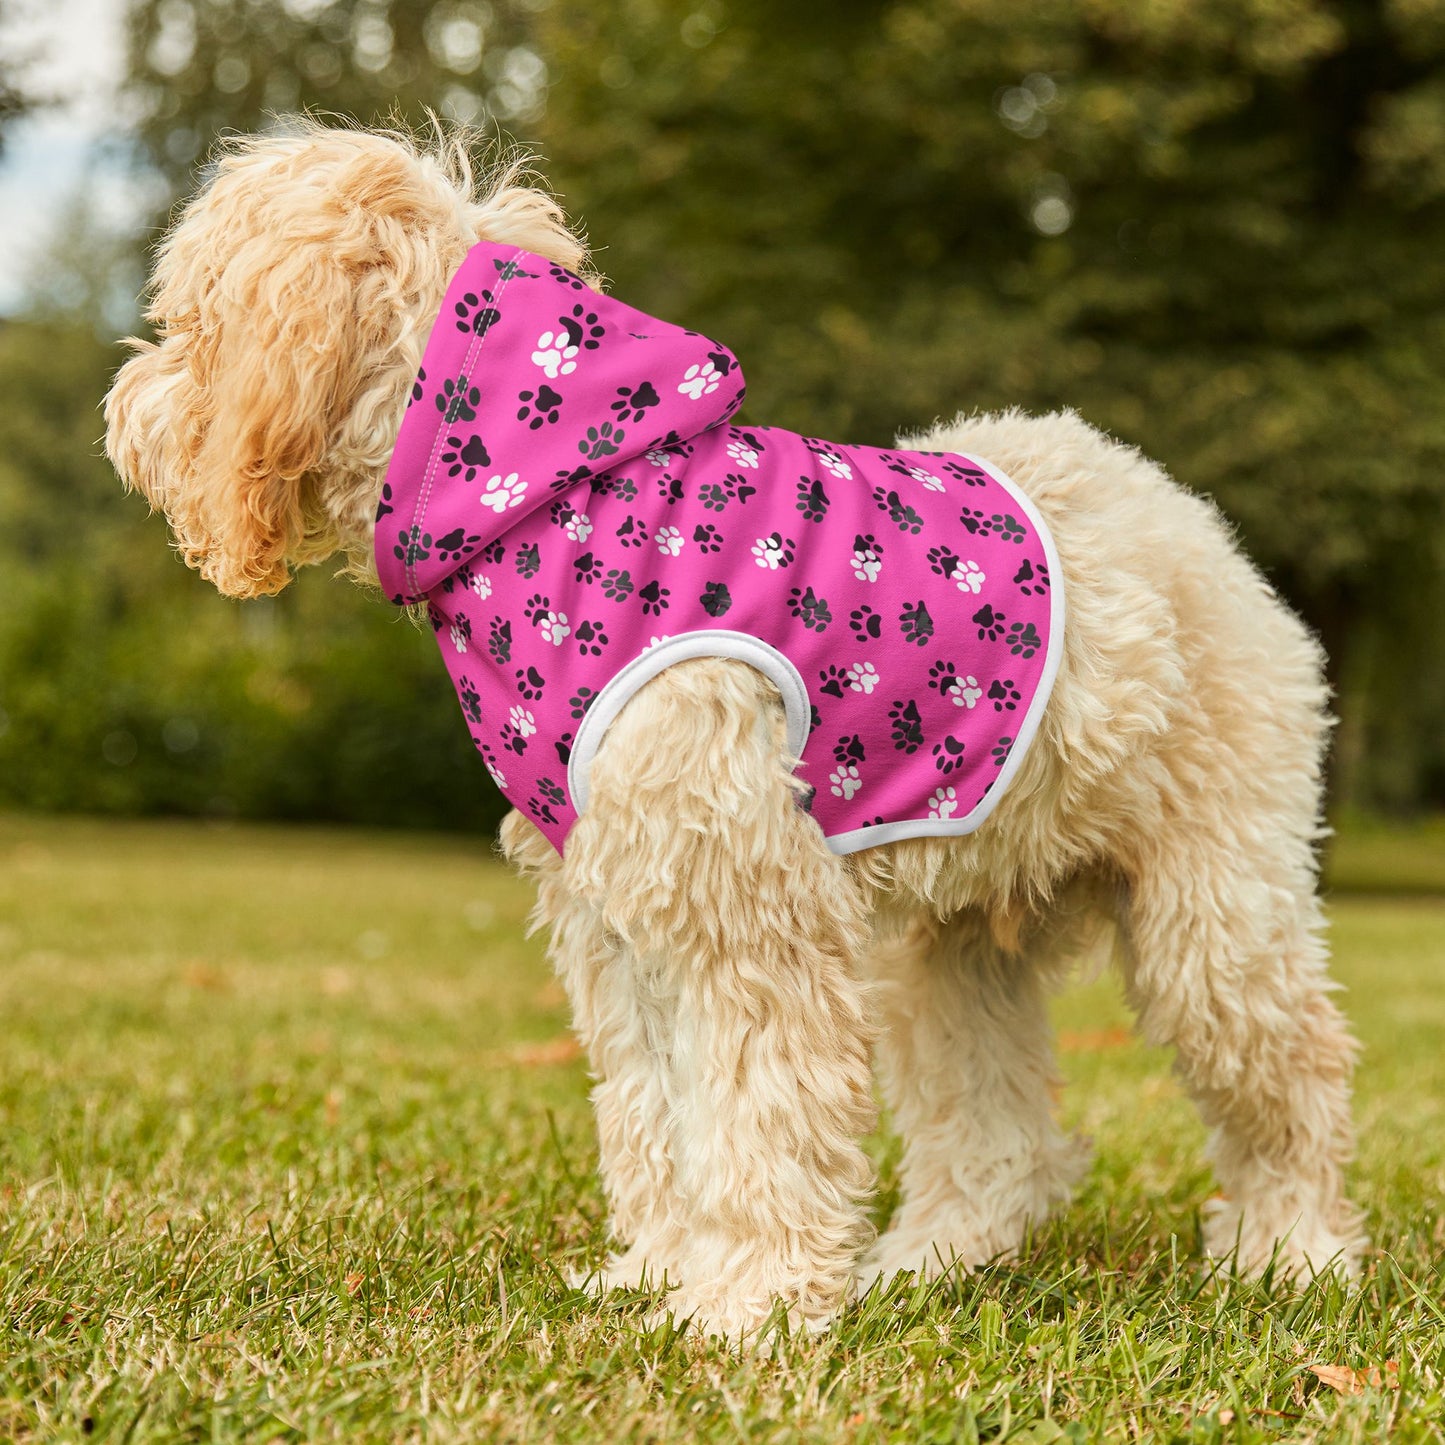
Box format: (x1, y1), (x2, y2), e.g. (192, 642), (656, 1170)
(0, 0), (1445, 827)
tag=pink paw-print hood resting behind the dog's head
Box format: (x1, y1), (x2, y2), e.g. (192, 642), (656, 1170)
(376, 241), (744, 604)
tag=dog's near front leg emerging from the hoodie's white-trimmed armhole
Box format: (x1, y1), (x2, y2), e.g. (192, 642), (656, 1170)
(564, 660), (874, 1340)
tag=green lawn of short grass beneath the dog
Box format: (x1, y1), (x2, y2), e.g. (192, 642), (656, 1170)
(0, 818), (1445, 1445)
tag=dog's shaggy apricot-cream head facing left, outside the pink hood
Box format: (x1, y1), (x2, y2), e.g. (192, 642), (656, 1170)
(105, 123), (585, 597)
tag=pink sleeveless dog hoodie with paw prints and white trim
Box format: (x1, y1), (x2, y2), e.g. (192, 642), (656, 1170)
(376, 243), (1064, 853)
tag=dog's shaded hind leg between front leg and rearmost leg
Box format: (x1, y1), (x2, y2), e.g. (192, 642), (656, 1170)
(860, 910), (1088, 1285)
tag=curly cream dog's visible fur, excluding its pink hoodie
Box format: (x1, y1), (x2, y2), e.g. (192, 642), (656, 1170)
(105, 126), (1364, 1338)
